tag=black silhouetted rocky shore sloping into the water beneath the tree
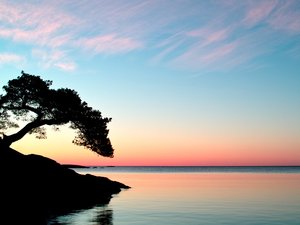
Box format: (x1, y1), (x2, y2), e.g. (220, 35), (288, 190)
(0, 149), (129, 224)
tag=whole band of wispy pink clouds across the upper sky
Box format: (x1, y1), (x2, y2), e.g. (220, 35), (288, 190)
(0, 0), (300, 71)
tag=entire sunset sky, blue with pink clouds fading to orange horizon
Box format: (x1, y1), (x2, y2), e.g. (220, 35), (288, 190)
(0, 0), (300, 166)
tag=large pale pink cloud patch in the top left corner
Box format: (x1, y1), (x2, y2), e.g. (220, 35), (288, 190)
(0, 2), (76, 47)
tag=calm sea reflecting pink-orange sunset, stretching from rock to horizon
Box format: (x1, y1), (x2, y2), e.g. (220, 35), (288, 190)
(48, 166), (300, 225)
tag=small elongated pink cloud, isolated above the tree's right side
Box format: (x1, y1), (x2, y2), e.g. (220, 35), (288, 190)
(78, 34), (142, 54)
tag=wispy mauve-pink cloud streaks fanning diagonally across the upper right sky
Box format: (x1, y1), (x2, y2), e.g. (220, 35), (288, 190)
(157, 0), (300, 70)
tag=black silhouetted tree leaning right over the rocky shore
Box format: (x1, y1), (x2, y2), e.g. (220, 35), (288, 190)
(0, 71), (114, 157)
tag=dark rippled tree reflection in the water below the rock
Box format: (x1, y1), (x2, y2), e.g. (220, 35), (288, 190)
(48, 205), (113, 225)
